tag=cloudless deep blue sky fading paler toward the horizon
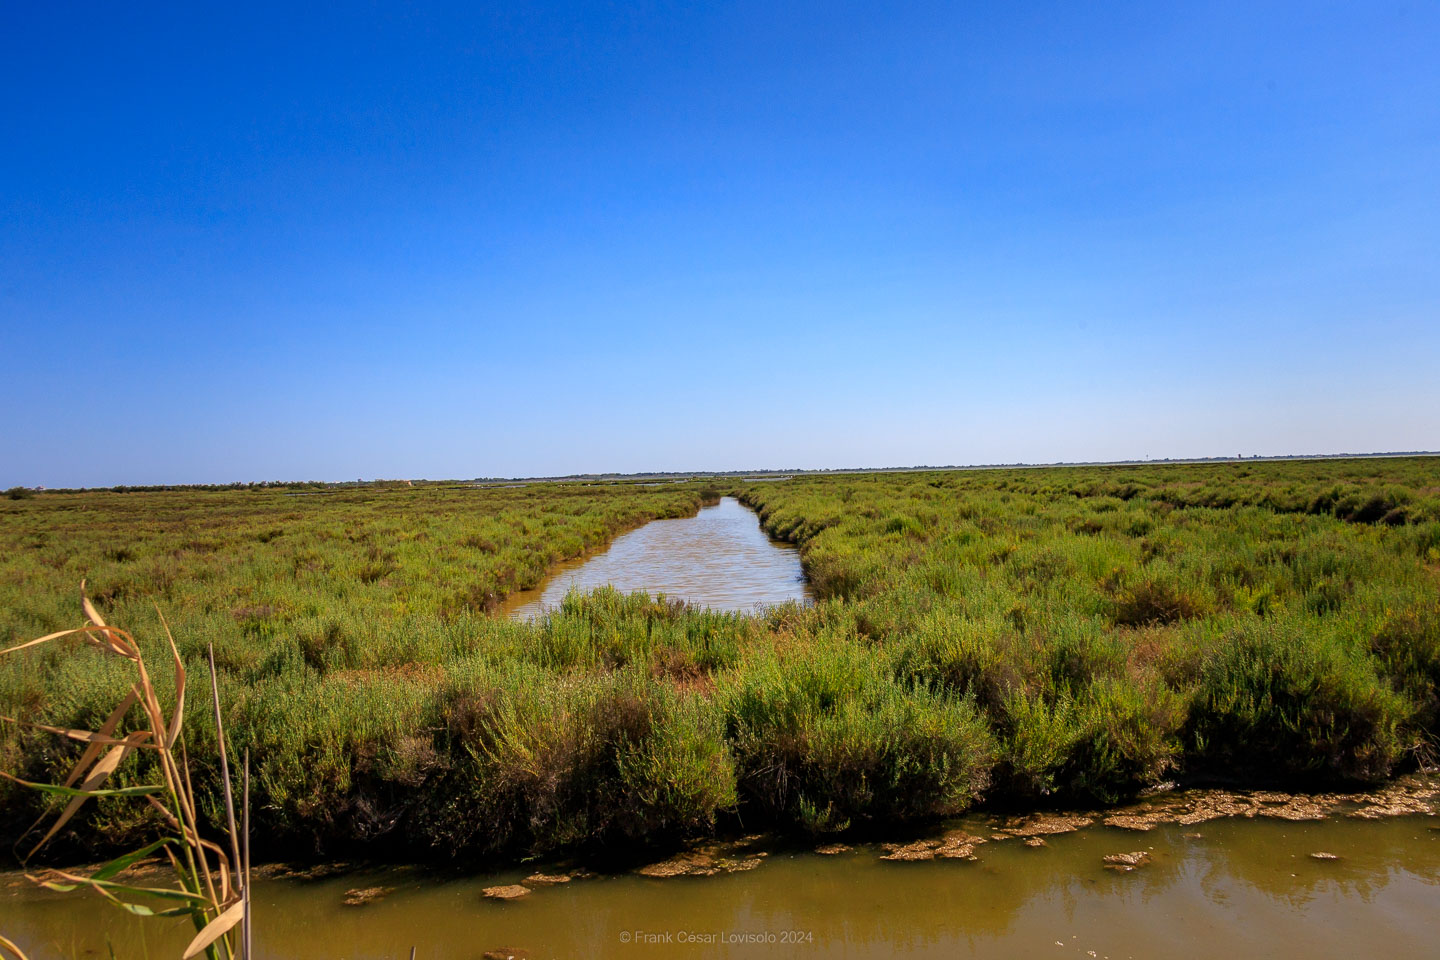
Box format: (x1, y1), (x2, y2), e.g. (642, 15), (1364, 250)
(0, 0), (1440, 486)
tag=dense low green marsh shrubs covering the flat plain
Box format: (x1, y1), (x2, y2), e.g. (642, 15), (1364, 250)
(0, 458), (1440, 856)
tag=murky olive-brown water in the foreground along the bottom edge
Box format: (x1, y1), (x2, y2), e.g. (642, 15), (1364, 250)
(0, 816), (1440, 960)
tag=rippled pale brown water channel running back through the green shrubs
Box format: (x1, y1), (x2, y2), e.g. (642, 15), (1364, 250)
(501, 497), (809, 619)
